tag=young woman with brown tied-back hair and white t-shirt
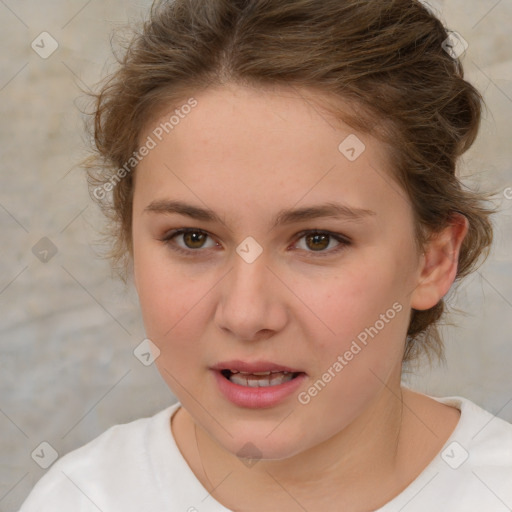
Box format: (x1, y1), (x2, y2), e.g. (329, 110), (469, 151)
(21, 0), (512, 512)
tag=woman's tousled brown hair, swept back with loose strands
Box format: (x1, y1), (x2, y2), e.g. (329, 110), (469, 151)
(87, 0), (494, 361)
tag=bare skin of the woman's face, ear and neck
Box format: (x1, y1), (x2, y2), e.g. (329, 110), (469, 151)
(132, 85), (467, 511)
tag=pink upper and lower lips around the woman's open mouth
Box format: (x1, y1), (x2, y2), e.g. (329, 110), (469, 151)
(211, 361), (307, 409)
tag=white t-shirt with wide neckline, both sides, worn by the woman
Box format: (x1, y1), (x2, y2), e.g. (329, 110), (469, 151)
(20, 396), (512, 512)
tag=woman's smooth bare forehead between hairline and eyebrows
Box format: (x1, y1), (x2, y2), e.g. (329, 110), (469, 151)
(135, 86), (406, 222)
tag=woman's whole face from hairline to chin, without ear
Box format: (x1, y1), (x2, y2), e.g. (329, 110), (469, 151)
(133, 86), (419, 459)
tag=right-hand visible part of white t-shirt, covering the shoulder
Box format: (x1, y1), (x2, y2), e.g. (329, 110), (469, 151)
(379, 396), (512, 512)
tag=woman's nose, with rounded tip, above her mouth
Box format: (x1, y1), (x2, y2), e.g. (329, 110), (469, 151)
(215, 250), (288, 341)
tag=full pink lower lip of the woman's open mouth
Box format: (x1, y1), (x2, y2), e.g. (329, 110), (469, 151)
(212, 370), (306, 409)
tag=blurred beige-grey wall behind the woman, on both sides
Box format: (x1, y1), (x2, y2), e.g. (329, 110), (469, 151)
(0, 0), (512, 512)
